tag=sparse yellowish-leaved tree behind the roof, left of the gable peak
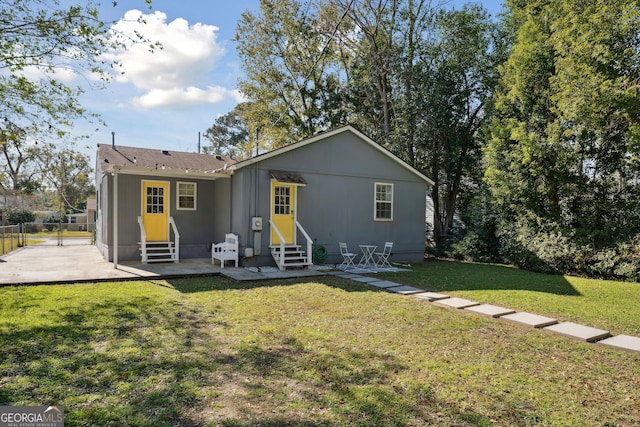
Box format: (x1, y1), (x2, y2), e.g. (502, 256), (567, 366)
(235, 0), (346, 147)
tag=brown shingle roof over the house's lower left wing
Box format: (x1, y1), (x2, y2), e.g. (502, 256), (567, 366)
(97, 144), (237, 172)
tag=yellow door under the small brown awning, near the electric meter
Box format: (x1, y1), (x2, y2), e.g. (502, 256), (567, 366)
(271, 181), (297, 245)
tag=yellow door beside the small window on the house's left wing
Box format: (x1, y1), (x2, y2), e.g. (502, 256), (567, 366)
(142, 181), (169, 242)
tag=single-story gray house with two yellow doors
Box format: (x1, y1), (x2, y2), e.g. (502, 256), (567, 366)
(96, 126), (433, 269)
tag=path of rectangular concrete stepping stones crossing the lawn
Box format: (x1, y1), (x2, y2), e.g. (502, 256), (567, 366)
(330, 272), (640, 353)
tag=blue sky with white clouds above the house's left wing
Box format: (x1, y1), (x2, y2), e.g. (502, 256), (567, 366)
(75, 0), (502, 160)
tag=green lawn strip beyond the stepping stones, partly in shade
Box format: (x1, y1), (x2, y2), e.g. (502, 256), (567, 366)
(379, 260), (640, 336)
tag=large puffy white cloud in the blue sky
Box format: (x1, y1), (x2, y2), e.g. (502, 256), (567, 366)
(101, 10), (229, 108)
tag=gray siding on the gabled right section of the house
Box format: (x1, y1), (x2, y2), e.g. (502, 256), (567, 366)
(233, 132), (427, 264)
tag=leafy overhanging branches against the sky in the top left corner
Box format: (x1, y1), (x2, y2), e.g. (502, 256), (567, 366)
(0, 0), (153, 144)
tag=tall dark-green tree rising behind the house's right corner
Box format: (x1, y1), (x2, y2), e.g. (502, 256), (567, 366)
(418, 5), (508, 243)
